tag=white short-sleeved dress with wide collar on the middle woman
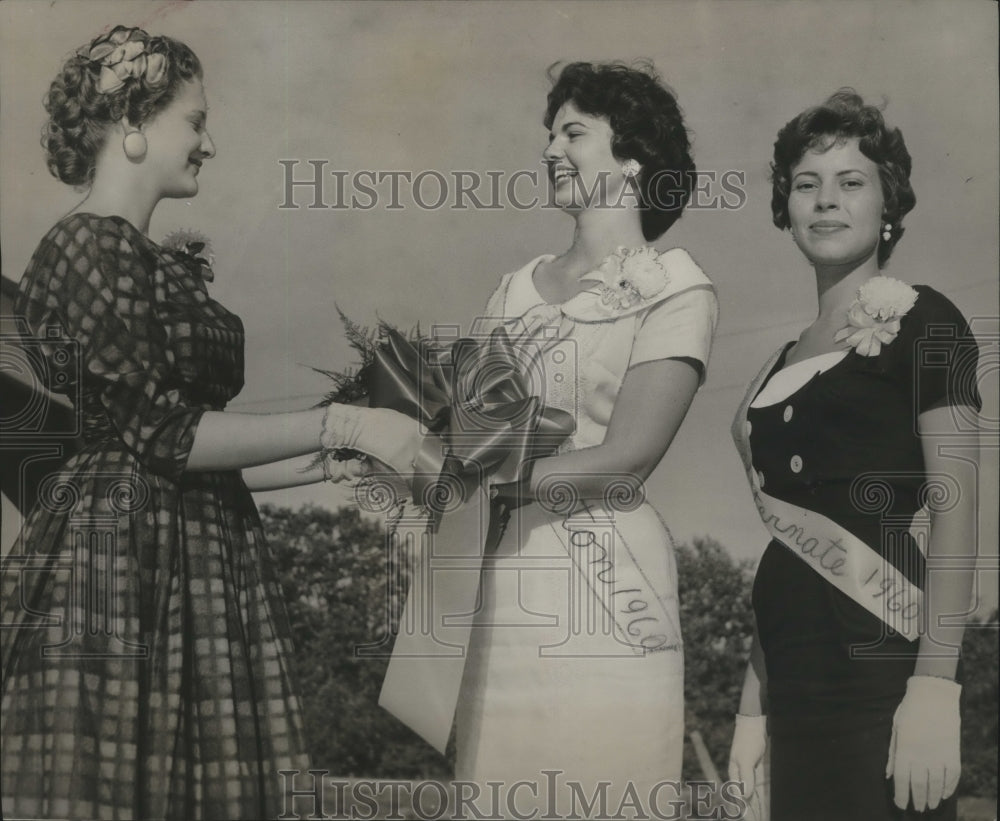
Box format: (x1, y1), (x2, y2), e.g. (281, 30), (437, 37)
(456, 249), (717, 817)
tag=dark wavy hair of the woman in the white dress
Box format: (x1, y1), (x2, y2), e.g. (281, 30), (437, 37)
(544, 62), (695, 241)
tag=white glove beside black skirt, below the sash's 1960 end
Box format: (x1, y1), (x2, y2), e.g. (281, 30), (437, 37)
(885, 676), (962, 812)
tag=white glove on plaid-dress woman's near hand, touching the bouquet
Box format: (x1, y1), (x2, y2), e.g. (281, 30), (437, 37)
(320, 403), (422, 476)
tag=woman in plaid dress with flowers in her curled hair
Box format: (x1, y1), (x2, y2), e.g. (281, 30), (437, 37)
(0, 27), (412, 819)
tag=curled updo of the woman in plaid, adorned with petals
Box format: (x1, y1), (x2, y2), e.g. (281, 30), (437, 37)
(42, 26), (202, 186)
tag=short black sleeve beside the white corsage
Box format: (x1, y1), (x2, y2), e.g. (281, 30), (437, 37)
(900, 285), (983, 413)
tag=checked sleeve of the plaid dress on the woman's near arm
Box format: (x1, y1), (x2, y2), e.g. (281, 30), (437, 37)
(17, 215), (204, 481)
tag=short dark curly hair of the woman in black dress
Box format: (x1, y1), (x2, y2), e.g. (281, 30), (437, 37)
(771, 88), (917, 268)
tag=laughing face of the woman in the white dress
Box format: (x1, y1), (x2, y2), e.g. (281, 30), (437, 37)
(542, 101), (627, 211)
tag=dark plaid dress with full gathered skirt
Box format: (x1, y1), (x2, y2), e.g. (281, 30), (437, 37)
(0, 214), (308, 820)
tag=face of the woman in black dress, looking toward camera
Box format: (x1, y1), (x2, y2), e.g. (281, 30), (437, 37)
(788, 137), (885, 266)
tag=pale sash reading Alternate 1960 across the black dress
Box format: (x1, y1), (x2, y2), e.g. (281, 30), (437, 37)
(732, 348), (923, 641)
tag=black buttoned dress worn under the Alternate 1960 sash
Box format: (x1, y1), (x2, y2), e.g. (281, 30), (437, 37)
(748, 286), (981, 821)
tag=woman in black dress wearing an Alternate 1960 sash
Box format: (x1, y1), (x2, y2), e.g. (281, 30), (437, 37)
(730, 89), (981, 821)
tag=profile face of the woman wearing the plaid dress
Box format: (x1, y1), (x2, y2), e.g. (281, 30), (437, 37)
(142, 80), (215, 197)
